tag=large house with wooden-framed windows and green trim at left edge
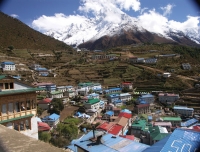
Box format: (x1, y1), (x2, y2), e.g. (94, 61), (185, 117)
(0, 75), (40, 139)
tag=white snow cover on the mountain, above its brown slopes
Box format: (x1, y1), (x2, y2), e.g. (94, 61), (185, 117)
(45, 8), (200, 46)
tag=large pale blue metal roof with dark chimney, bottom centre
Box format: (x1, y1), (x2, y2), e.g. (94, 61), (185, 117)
(67, 131), (149, 152)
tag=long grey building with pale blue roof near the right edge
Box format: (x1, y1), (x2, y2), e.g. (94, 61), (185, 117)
(173, 106), (194, 117)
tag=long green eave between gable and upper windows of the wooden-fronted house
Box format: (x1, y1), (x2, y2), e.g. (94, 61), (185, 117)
(0, 88), (44, 95)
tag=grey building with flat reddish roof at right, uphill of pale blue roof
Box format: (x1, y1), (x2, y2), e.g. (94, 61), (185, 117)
(158, 93), (179, 104)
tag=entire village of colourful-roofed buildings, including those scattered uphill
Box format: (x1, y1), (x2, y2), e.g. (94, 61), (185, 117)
(0, 47), (200, 152)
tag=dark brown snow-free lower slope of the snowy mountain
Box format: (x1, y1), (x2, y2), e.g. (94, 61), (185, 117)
(78, 30), (200, 50)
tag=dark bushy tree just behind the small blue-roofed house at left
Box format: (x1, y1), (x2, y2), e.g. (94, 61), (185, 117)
(48, 98), (64, 115)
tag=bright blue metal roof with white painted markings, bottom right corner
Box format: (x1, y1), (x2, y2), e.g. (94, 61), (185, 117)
(161, 129), (200, 152)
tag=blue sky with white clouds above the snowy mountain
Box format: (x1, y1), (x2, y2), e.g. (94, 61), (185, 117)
(0, 0), (200, 35)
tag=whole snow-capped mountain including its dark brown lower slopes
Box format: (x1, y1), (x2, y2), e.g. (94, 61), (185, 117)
(45, 9), (200, 48)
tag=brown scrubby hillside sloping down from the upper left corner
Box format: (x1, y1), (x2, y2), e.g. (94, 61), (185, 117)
(0, 12), (70, 50)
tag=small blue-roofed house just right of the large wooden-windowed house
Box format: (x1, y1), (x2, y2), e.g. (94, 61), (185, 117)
(42, 113), (60, 127)
